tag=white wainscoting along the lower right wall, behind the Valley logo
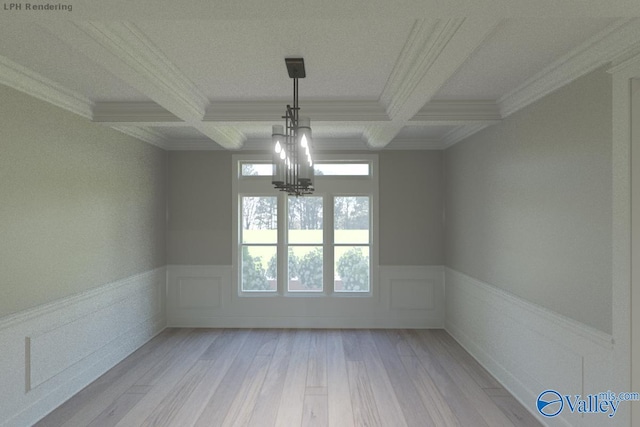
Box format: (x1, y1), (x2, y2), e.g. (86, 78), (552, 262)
(445, 268), (616, 427)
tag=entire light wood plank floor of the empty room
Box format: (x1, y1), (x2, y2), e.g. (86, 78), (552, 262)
(36, 329), (540, 427)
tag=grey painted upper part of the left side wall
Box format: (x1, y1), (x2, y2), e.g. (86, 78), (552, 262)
(0, 86), (166, 317)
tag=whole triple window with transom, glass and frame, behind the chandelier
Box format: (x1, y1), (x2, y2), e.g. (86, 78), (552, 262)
(233, 154), (377, 297)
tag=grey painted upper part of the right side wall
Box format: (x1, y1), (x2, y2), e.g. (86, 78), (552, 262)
(444, 70), (612, 333)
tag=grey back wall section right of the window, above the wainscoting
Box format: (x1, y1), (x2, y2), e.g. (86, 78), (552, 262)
(379, 151), (444, 265)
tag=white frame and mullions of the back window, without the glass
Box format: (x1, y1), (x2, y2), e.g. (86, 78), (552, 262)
(231, 153), (379, 298)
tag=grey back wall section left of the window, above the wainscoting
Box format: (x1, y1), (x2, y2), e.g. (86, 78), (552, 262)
(167, 151), (232, 265)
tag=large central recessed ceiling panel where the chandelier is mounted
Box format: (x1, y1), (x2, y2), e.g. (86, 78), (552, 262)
(137, 19), (413, 100)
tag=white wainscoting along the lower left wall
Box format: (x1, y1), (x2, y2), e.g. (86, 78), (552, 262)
(0, 267), (166, 427)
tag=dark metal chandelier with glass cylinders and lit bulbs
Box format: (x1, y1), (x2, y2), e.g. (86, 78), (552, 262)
(271, 58), (314, 196)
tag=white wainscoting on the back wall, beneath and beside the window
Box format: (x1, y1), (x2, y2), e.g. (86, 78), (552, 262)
(167, 265), (444, 328)
